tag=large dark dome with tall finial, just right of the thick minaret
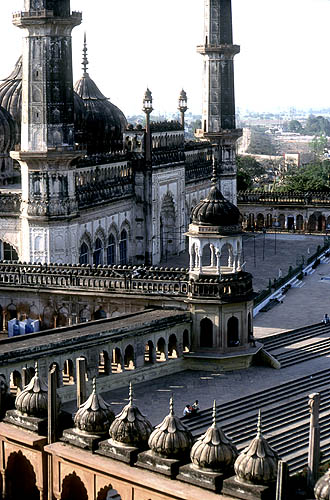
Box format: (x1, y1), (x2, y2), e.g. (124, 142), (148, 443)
(74, 35), (127, 154)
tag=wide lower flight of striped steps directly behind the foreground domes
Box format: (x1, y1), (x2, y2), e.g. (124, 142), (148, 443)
(183, 370), (330, 473)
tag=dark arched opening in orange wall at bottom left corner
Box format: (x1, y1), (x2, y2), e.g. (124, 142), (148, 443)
(5, 451), (40, 500)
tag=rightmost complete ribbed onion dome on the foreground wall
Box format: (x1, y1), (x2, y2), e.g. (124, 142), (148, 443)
(234, 410), (279, 484)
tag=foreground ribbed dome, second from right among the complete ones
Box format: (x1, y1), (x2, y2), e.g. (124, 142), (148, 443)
(190, 401), (238, 472)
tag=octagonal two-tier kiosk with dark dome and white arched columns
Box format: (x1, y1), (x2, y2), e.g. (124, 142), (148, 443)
(184, 159), (262, 370)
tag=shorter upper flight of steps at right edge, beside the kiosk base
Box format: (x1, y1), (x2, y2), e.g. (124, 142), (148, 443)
(258, 323), (330, 368)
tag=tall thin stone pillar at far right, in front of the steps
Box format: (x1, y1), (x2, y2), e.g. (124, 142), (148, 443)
(307, 392), (320, 489)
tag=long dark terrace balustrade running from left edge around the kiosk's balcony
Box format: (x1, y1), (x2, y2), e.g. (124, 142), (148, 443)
(0, 261), (253, 300)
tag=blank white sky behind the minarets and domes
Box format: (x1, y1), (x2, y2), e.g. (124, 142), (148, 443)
(0, 0), (330, 115)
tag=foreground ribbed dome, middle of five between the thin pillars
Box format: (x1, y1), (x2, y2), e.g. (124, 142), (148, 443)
(148, 398), (193, 459)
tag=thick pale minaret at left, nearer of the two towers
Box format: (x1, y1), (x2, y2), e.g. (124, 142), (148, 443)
(11, 0), (81, 262)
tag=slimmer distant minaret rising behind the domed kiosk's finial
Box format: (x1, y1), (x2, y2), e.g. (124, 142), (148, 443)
(197, 0), (242, 204)
